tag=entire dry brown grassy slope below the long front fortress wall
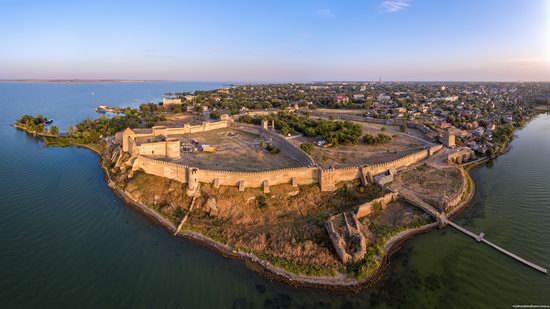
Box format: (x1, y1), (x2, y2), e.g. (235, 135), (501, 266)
(118, 172), (383, 276)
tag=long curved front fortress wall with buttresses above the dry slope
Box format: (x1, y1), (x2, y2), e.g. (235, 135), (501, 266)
(133, 141), (442, 192)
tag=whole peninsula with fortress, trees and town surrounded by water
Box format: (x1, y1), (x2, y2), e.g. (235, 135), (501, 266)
(16, 83), (548, 289)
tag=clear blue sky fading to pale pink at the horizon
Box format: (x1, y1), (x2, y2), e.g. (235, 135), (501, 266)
(0, 0), (550, 81)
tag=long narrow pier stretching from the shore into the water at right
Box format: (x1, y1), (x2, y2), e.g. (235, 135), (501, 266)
(399, 189), (548, 274)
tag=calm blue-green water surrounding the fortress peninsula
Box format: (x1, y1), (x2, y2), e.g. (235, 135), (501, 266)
(0, 83), (550, 308)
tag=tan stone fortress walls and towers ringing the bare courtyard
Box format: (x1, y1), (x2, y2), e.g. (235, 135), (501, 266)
(118, 119), (443, 195)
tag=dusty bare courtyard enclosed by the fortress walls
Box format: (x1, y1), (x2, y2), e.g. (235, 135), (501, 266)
(172, 128), (301, 171)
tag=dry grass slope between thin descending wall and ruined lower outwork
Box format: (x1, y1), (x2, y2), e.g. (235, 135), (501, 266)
(189, 183), (382, 275)
